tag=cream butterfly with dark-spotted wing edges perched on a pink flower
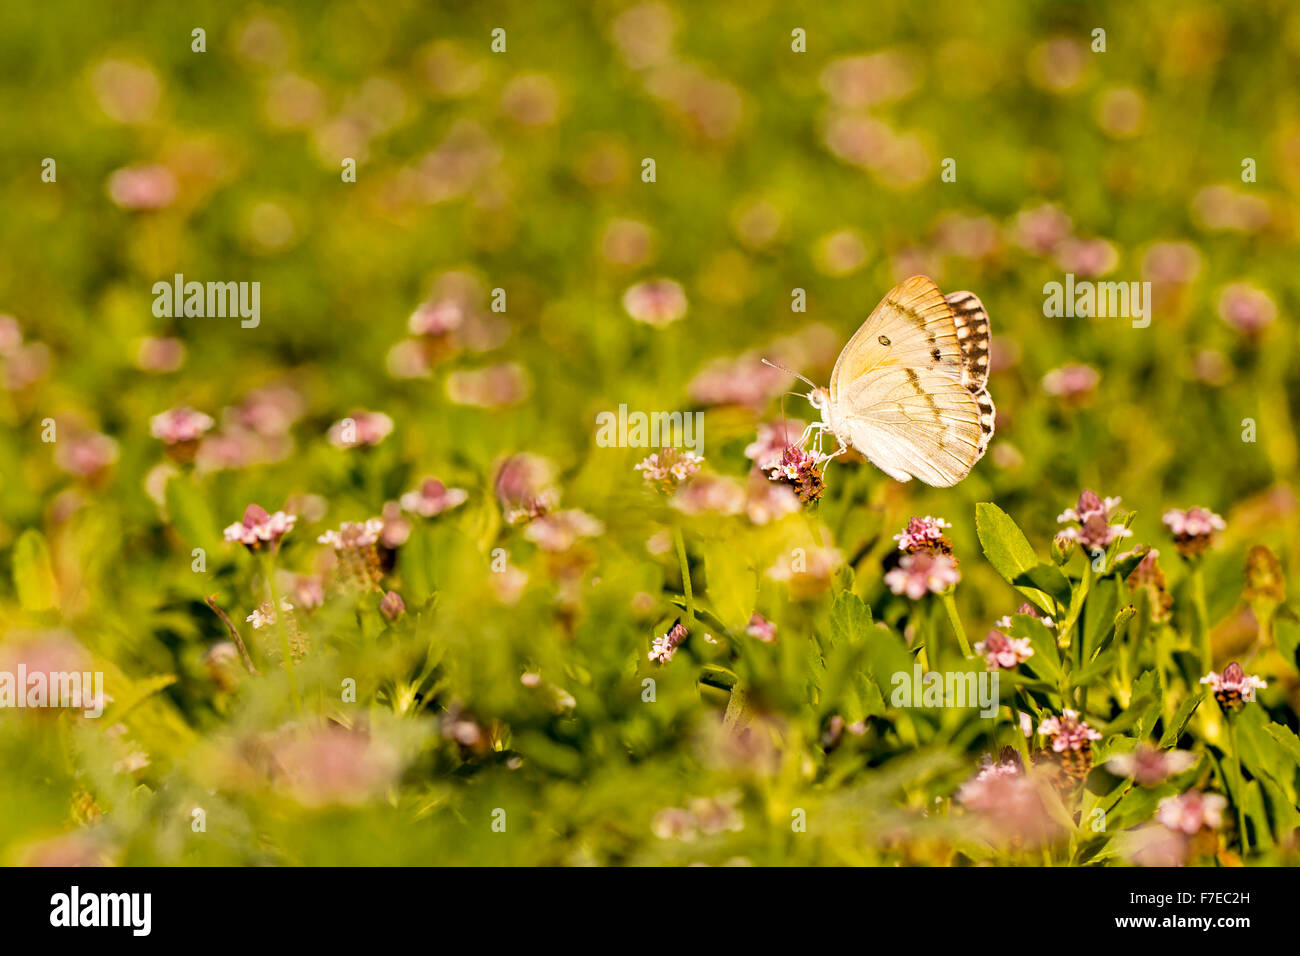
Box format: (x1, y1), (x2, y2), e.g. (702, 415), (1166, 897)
(769, 276), (993, 488)
